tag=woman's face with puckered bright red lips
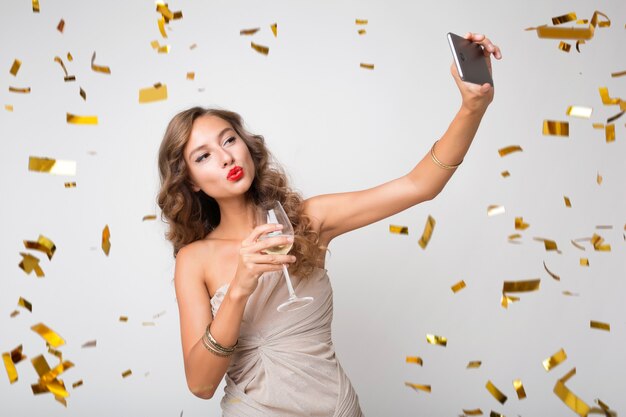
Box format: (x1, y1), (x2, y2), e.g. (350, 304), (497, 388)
(183, 115), (254, 200)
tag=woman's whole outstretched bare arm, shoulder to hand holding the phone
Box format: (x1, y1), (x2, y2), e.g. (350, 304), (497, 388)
(305, 33), (501, 241)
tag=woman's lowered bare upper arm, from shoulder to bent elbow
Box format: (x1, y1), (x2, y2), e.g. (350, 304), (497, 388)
(174, 245), (213, 370)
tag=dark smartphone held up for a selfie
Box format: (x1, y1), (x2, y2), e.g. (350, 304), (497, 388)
(448, 32), (493, 87)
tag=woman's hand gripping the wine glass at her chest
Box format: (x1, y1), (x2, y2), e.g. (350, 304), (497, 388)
(231, 223), (296, 297)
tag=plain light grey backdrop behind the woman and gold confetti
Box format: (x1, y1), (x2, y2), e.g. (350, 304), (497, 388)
(0, 0), (626, 417)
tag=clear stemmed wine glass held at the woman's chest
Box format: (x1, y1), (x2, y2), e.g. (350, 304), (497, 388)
(257, 201), (313, 312)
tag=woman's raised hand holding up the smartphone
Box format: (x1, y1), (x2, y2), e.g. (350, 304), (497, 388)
(450, 32), (502, 112)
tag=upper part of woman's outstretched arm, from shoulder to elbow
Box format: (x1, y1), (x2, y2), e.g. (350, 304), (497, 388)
(304, 176), (433, 241)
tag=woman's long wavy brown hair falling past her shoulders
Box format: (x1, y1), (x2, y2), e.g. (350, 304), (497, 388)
(157, 107), (326, 277)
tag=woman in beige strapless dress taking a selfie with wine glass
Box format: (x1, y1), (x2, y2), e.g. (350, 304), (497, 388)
(158, 33), (501, 417)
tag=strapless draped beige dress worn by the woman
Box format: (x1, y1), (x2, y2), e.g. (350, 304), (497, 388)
(211, 268), (363, 417)
